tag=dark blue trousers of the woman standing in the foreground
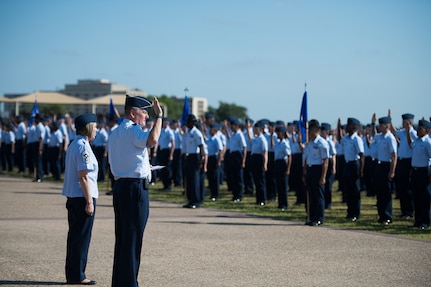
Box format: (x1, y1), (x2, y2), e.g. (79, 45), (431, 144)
(65, 197), (96, 283)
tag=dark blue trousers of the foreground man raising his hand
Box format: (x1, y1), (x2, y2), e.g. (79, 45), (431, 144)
(112, 178), (149, 287)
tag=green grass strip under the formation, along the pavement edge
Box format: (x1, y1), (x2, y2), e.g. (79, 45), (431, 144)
(0, 171), (431, 241)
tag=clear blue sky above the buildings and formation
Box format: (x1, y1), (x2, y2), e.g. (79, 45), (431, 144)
(0, 0), (431, 124)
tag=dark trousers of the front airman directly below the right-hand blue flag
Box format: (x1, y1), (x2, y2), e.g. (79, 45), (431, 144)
(306, 165), (325, 223)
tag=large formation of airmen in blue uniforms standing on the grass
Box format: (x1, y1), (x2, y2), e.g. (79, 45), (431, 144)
(0, 109), (431, 229)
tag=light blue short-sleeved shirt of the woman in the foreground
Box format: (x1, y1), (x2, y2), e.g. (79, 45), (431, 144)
(62, 135), (99, 198)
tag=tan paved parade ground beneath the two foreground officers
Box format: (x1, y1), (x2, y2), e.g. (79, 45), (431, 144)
(0, 175), (431, 287)
